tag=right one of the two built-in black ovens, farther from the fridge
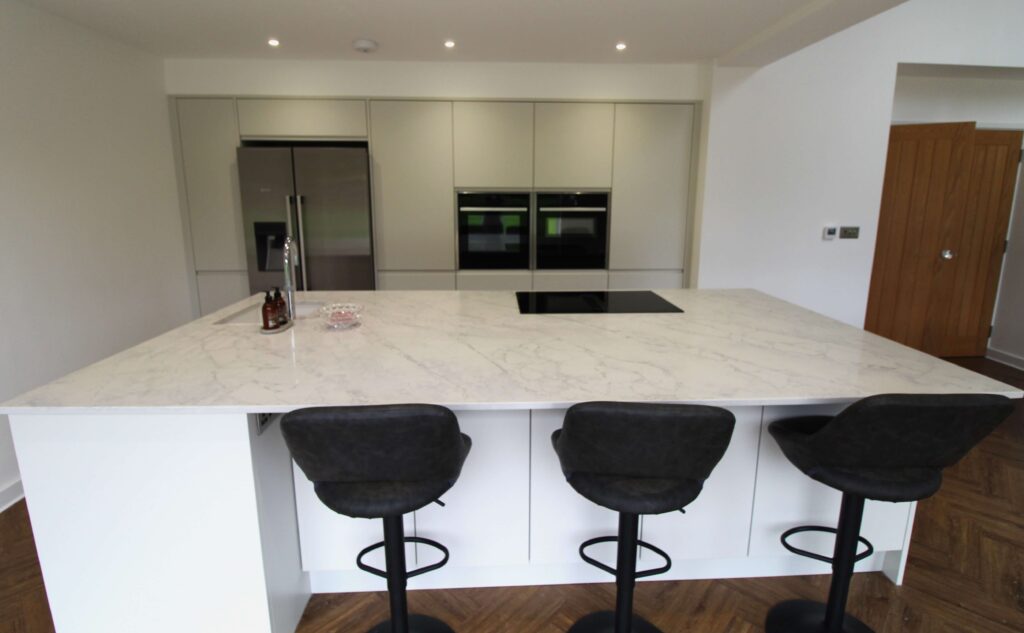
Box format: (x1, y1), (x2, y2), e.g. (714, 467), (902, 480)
(537, 192), (608, 269)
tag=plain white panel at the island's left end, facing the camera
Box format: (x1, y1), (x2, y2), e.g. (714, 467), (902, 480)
(11, 414), (294, 633)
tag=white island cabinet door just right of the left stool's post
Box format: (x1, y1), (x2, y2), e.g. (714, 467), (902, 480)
(410, 411), (529, 588)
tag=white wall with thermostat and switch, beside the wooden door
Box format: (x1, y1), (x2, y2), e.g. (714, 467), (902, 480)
(697, 0), (1024, 326)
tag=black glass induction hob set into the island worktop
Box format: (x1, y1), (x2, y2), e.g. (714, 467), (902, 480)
(515, 290), (683, 314)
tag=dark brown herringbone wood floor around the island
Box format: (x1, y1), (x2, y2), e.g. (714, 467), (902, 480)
(0, 358), (1024, 633)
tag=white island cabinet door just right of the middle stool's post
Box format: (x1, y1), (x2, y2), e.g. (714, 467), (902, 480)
(640, 407), (761, 557)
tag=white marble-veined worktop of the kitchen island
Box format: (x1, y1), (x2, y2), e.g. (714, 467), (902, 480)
(0, 290), (1022, 413)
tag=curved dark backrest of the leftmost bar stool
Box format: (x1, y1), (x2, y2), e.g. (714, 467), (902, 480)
(281, 405), (463, 483)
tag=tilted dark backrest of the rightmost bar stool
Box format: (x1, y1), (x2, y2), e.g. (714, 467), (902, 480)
(808, 394), (1014, 468)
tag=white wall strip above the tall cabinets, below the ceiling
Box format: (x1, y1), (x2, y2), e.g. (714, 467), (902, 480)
(165, 59), (708, 100)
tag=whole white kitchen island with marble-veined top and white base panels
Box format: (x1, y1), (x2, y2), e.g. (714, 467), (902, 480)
(0, 290), (1024, 633)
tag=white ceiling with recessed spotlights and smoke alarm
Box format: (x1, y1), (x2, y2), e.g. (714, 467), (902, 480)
(25, 0), (898, 64)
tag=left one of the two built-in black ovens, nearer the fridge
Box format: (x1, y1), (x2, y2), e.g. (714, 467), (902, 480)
(458, 192), (529, 269)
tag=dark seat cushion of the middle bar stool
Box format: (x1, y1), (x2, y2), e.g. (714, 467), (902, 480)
(568, 472), (703, 514)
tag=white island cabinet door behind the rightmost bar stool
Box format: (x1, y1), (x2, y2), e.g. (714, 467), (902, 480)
(751, 405), (912, 557)
